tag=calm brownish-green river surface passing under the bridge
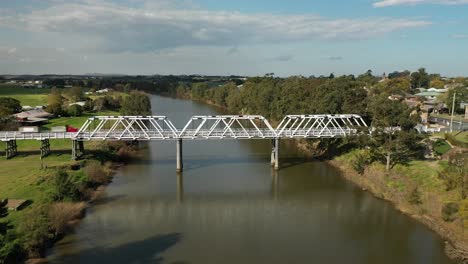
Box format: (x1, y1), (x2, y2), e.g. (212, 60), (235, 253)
(48, 96), (452, 264)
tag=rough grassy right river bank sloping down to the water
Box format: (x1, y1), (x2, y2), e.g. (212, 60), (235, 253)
(330, 150), (468, 263)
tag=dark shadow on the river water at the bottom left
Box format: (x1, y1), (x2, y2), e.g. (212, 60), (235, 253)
(56, 233), (186, 264)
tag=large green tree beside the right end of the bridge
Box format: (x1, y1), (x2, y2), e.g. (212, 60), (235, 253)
(370, 96), (423, 170)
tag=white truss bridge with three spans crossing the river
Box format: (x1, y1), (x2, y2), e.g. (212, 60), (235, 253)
(0, 115), (367, 141)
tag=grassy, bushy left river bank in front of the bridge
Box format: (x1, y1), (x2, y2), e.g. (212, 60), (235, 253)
(0, 139), (137, 263)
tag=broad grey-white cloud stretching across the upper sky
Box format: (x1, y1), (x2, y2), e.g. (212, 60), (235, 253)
(0, 0), (431, 52)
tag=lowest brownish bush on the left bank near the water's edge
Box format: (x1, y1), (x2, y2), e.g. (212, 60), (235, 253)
(48, 202), (86, 235)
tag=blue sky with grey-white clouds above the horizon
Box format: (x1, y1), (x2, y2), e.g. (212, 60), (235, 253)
(0, 0), (468, 76)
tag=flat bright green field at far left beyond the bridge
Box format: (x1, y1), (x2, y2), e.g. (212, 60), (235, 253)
(0, 84), (50, 106)
